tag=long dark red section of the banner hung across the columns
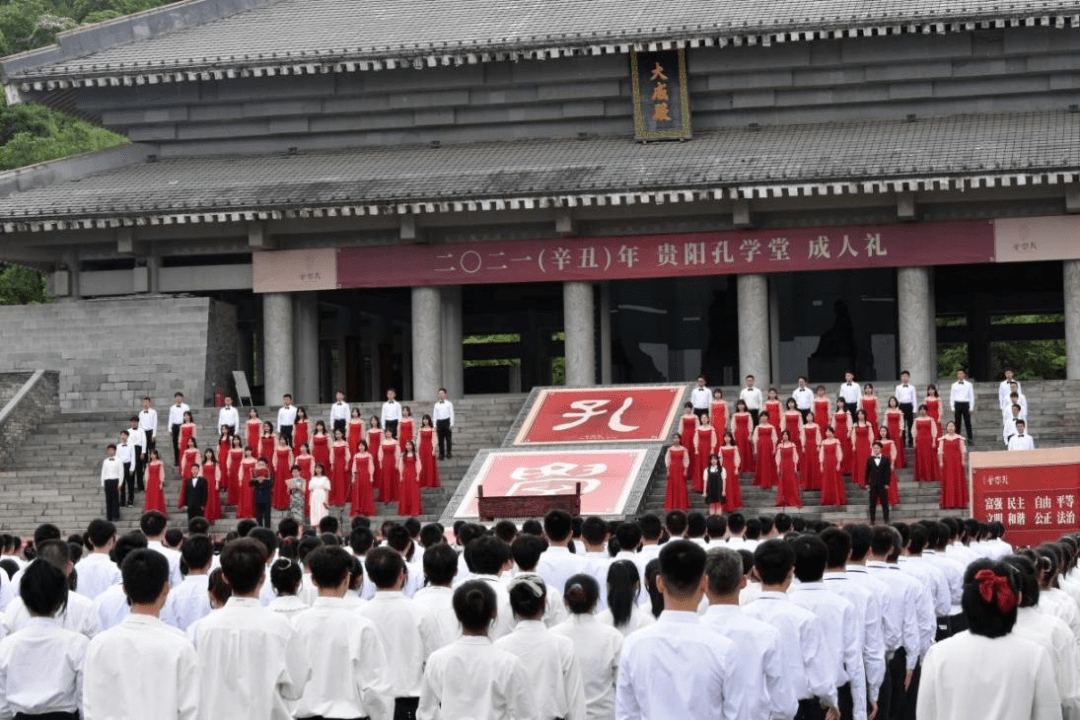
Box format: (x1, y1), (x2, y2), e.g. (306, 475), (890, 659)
(337, 220), (994, 287)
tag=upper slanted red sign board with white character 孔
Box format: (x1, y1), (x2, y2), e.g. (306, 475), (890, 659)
(514, 385), (686, 445)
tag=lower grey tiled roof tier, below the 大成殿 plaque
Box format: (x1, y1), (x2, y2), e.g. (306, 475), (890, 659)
(0, 112), (1080, 232)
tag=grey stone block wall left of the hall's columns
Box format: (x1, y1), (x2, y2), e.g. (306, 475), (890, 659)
(0, 297), (237, 412)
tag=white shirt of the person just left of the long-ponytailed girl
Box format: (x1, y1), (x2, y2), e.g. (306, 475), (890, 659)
(552, 614), (623, 720)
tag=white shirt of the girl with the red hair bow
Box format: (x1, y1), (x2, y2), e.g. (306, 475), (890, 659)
(916, 630), (1062, 720)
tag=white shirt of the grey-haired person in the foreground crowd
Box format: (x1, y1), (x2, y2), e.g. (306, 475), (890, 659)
(701, 604), (799, 718)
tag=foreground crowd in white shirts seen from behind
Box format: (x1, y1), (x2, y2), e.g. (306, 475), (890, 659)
(0, 511), (1080, 720)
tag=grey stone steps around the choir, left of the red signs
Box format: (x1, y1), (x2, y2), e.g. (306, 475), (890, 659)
(0, 395), (525, 535)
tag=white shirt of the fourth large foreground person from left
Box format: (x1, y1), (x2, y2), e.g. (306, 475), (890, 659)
(293, 597), (394, 718)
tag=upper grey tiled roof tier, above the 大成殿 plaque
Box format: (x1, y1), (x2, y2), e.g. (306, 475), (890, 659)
(3, 0), (1080, 91)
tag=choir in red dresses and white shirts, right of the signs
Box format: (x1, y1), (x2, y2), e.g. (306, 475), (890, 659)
(664, 369), (1035, 520)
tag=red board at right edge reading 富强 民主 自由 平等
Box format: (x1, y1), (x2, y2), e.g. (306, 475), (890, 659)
(971, 462), (1080, 547)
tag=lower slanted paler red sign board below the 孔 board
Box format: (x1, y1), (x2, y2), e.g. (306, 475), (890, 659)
(454, 448), (647, 518)
